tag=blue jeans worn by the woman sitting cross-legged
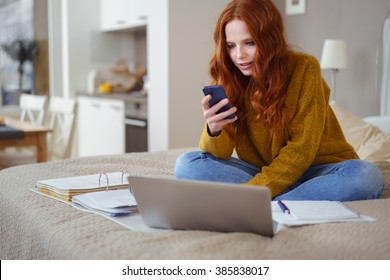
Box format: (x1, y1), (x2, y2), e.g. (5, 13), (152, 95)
(175, 151), (384, 201)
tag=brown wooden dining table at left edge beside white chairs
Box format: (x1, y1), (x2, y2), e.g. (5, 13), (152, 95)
(0, 118), (52, 162)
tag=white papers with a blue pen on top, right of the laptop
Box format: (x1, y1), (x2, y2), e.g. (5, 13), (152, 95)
(272, 200), (375, 226)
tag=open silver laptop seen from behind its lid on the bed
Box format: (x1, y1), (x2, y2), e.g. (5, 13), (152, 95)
(128, 176), (274, 236)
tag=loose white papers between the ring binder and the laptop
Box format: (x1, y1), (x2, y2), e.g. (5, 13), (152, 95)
(72, 189), (137, 216)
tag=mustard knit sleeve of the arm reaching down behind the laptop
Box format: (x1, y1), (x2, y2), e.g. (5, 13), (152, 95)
(247, 57), (327, 197)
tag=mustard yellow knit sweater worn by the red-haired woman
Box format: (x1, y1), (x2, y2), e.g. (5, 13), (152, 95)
(199, 52), (358, 197)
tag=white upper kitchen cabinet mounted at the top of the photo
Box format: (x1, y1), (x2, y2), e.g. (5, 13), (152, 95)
(100, 0), (148, 31)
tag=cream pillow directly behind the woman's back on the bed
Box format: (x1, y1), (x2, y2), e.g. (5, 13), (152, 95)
(330, 101), (390, 161)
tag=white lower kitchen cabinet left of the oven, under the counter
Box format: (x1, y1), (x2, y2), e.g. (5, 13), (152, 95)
(78, 96), (125, 157)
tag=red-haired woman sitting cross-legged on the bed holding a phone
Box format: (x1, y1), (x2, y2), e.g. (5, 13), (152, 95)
(175, 0), (384, 201)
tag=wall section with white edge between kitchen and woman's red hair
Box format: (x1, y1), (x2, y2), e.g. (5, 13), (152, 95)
(148, 0), (229, 151)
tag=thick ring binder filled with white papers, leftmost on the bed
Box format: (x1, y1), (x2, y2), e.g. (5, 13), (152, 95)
(36, 172), (129, 201)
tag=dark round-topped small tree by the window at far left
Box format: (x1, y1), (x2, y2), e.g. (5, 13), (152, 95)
(2, 39), (39, 91)
